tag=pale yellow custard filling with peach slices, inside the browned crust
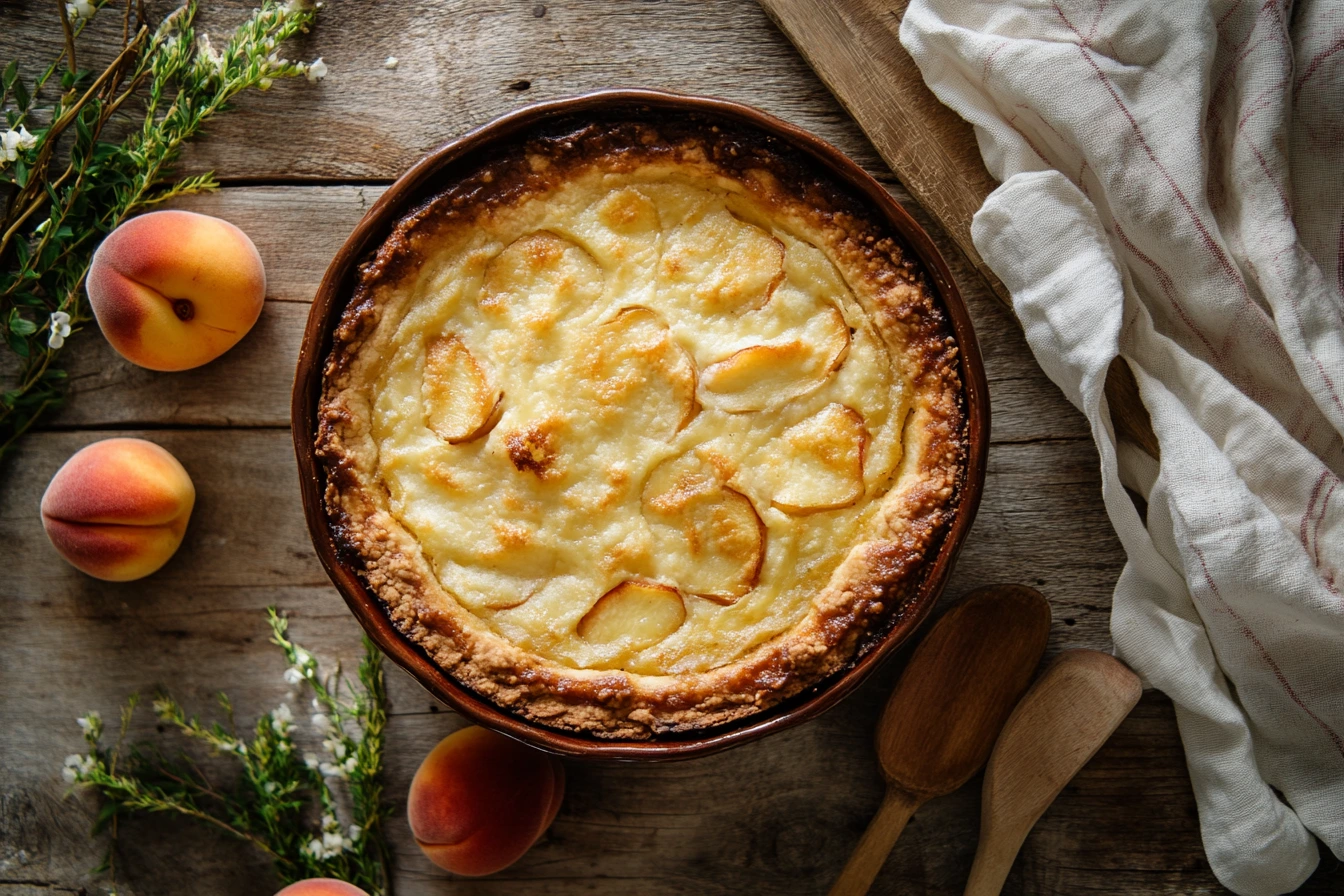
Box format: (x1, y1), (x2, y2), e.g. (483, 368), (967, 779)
(372, 167), (909, 674)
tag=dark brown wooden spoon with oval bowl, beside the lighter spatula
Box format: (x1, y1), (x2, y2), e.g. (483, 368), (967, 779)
(831, 584), (1050, 896)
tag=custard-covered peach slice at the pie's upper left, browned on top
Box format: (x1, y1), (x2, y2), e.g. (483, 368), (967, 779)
(477, 231), (605, 330)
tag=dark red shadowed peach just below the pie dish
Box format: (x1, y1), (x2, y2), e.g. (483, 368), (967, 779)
(406, 727), (564, 877)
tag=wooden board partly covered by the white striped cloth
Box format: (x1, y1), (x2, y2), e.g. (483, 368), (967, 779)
(758, 0), (1159, 457)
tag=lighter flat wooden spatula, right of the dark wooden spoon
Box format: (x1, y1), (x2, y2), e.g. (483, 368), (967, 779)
(965, 650), (1144, 896)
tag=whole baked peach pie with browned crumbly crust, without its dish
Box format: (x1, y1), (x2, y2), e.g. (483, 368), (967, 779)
(317, 124), (964, 737)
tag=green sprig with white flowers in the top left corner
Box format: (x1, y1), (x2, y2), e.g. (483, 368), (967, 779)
(0, 0), (327, 462)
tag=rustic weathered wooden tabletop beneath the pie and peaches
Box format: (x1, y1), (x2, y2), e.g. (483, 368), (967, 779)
(0, 0), (1344, 896)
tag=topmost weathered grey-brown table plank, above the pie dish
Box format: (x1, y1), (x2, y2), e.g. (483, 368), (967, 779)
(0, 0), (882, 183)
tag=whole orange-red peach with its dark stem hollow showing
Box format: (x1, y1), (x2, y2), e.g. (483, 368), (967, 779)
(89, 211), (266, 371)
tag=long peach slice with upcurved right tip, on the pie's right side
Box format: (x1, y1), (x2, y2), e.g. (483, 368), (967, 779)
(700, 305), (849, 414)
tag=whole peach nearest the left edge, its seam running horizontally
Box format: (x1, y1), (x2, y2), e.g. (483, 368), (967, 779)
(42, 439), (196, 582)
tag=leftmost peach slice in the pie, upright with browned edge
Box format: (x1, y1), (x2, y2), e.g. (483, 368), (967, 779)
(421, 333), (504, 445)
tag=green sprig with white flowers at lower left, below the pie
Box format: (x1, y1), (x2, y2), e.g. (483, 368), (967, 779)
(63, 607), (392, 896)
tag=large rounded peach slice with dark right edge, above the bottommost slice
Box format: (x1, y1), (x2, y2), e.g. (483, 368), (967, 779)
(642, 453), (766, 603)
